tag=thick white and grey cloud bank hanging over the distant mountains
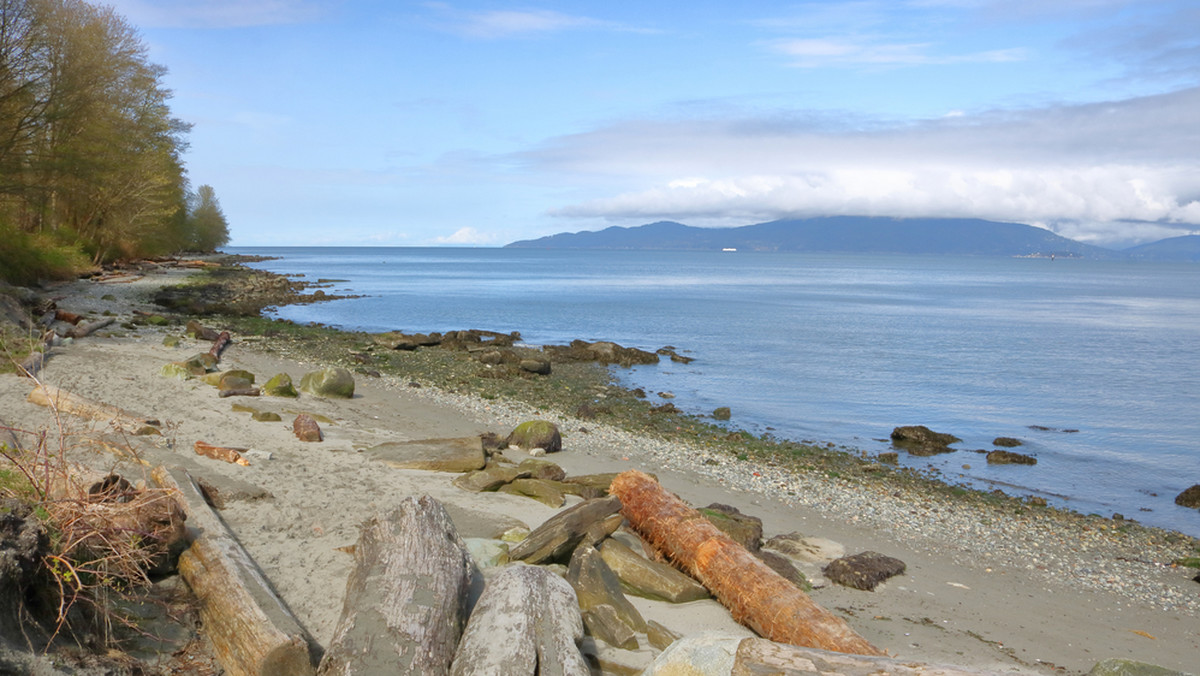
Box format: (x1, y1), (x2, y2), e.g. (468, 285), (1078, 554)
(529, 89), (1200, 241)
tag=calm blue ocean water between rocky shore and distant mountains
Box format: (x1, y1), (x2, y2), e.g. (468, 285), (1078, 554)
(230, 247), (1200, 536)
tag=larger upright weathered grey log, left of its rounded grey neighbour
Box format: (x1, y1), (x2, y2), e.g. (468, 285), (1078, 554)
(317, 496), (474, 676)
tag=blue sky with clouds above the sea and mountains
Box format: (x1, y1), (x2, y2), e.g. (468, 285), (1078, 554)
(106, 0), (1200, 247)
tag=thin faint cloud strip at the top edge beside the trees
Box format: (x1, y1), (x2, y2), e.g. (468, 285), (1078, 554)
(104, 0), (328, 28)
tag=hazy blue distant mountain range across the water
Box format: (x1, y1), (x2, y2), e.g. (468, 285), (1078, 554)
(506, 216), (1200, 261)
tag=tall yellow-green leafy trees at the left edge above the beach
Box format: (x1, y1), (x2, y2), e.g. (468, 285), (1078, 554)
(0, 0), (213, 270)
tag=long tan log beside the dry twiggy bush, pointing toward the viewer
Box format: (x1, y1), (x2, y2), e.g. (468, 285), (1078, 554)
(152, 467), (313, 676)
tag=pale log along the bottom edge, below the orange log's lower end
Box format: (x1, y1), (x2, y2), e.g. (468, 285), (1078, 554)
(730, 639), (989, 676)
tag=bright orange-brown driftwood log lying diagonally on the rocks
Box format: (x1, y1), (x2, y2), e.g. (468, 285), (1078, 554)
(610, 469), (884, 656)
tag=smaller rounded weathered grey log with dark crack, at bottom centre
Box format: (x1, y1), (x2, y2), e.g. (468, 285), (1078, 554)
(450, 563), (588, 676)
